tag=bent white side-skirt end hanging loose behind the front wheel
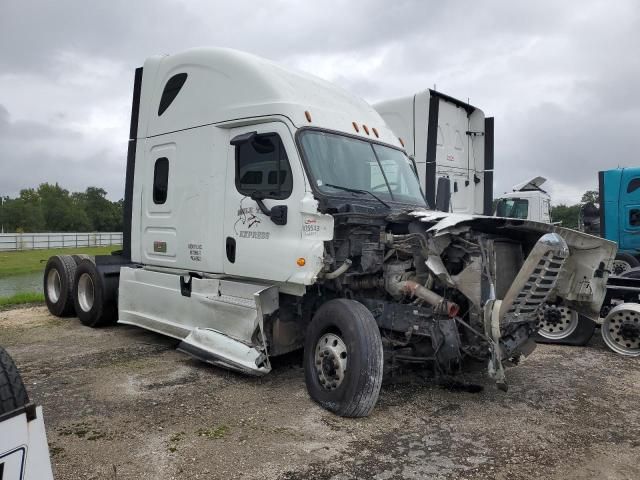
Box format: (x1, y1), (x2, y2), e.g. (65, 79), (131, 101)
(178, 286), (279, 375)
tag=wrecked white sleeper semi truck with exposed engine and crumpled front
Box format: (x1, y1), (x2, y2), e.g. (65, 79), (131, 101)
(45, 49), (615, 416)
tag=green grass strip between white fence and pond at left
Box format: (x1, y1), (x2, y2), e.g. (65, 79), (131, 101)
(0, 245), (121, 278)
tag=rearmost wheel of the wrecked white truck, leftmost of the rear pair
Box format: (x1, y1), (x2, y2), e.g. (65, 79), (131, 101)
(43, 255), (76, 317)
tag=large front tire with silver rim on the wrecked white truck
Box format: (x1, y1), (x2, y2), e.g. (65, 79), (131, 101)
(304, 299), (383, 417)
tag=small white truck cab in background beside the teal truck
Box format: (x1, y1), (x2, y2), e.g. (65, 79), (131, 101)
(495, 177), (551, 223)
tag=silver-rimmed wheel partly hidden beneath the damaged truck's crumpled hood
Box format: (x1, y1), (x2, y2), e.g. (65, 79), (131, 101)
(536, 304), (596, 346)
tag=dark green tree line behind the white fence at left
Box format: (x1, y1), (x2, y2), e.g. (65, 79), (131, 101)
(0, 183), (124, 233)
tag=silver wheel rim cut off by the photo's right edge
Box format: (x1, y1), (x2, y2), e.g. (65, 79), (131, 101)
(601, 304), (640, 357)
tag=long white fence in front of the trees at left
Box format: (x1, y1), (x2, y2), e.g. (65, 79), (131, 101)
(0, 232), (122, 252)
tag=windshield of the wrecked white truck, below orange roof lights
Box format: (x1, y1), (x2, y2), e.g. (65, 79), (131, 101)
(300, 130), (426, 206)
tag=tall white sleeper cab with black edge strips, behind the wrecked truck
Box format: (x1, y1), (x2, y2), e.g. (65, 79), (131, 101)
(373, 89), (493, 215)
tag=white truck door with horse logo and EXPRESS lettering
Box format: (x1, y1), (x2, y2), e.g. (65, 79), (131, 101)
(222, 122), (305, 282)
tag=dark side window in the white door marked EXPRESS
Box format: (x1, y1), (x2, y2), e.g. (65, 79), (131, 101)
(236, 133), (293, 200)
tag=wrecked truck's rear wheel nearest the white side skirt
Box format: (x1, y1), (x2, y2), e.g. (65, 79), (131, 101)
(73, 259), (118, 328)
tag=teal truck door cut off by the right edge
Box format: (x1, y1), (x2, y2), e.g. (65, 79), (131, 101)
(618, 169), (640, 251)
